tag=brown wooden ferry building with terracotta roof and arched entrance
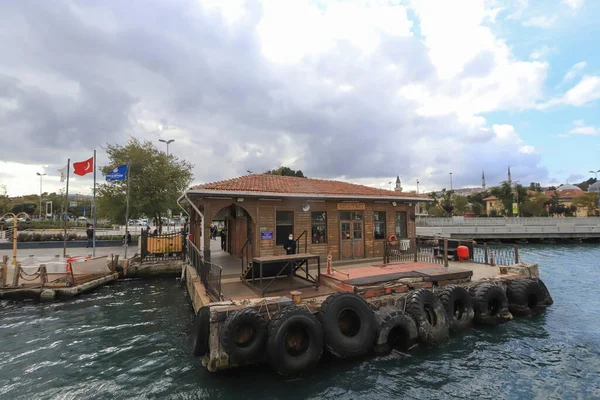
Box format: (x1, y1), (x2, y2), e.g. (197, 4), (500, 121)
(180, 174), (431, 261)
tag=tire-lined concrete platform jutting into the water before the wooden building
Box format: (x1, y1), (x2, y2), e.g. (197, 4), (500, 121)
(182, 255), (552, 375)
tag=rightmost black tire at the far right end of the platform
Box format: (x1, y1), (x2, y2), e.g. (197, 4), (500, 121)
(506, 278), (546, 317)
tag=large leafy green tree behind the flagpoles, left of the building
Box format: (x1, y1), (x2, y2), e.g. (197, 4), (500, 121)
(98, 138), (193, 230)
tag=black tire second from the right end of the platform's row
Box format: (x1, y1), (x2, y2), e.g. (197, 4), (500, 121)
(469, 283), (512, 325)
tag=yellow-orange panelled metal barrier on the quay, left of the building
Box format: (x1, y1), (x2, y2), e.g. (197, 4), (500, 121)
(140, 231), (187, 262)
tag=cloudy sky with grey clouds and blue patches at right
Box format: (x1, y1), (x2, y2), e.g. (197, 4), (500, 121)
(0, 0), (600, 195)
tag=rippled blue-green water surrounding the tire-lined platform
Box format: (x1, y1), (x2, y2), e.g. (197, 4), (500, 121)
(0, 245), (600, 399)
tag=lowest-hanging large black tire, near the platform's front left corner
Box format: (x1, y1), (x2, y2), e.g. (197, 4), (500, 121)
(267, 306), (325, 375)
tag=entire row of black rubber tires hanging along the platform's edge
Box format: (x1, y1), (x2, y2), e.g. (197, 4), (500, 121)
(192, 279), (552, 375)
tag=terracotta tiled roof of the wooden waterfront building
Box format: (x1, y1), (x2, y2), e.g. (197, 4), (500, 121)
(192, 174), (430, 200)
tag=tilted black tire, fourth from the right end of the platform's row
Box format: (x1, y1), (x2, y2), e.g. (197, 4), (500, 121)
(405, 289), (449, 344)
